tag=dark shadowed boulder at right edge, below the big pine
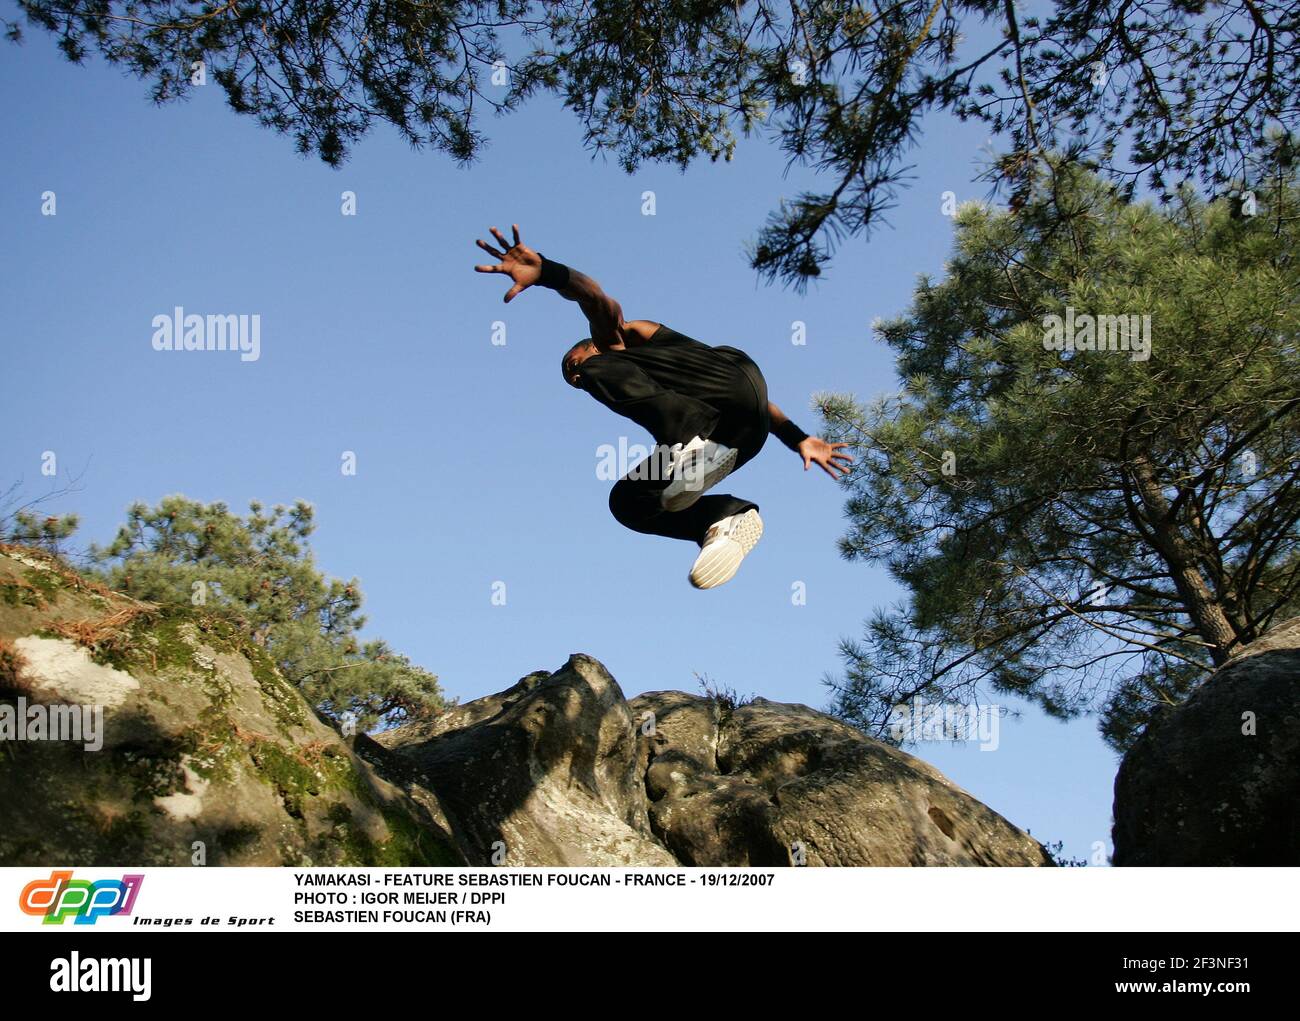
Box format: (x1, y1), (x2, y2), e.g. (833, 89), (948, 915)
(1113, 619), (1300, 865)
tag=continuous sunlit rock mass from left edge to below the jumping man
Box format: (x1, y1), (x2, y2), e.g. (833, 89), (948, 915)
(0, 548), (1050, 866)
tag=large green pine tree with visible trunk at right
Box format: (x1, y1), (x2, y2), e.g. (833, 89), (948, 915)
(823, 165), (1300, 747)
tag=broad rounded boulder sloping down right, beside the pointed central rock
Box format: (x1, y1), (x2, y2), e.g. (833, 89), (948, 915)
(632, 692), (1052, 865)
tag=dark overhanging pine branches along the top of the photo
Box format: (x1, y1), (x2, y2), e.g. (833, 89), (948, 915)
(8, 0), (1300, 286)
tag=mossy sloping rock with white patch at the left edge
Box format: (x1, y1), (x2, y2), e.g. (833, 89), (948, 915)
(0, 548), (463, 865)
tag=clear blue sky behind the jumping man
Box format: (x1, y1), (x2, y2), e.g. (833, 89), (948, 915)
(0, 23), (1117, 857)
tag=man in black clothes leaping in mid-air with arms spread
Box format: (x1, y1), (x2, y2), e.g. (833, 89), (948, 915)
(475, 224), (853, 588)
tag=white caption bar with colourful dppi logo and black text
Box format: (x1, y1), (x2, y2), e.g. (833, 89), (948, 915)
(0, 866), (1300, 933)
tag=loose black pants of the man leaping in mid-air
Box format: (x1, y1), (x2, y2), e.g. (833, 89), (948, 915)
(581, 354), (771, 544)
